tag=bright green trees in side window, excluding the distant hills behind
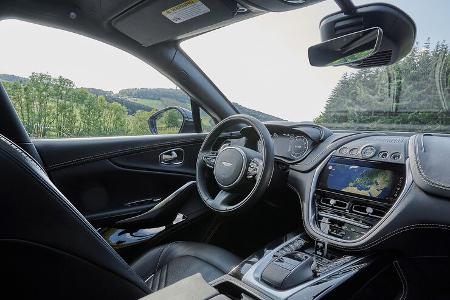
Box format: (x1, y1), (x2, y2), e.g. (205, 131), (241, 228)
(3, 73), (156, 138)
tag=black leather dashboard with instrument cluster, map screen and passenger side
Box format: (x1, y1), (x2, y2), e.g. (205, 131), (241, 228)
(230, 122), (450, 251)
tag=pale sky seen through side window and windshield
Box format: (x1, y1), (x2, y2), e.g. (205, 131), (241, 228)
(0, 0), (450, 121)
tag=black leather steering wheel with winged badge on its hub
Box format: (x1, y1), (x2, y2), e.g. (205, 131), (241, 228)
(196, 114), (274, 215)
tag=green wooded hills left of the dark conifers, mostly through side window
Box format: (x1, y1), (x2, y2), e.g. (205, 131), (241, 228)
(0, 73), (281, 138)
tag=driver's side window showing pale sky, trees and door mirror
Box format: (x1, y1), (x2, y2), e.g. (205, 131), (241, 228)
(0, 20), (199, 138)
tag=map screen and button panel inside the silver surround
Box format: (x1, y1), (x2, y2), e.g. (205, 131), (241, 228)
(312, 156), (405, 241)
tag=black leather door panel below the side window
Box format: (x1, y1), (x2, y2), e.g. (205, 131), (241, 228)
(34, 134), (205, 226)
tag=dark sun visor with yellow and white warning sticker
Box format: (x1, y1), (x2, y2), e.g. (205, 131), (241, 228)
(112, 0), (237, 46)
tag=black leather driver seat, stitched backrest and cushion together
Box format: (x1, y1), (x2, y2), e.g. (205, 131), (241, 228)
(0, 135), (240, 299)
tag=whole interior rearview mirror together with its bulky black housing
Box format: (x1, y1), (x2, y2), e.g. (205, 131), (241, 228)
(308, 1), (416, 68)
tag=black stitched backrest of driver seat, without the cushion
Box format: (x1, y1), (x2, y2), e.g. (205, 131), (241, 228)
(0, 135), (149, 299)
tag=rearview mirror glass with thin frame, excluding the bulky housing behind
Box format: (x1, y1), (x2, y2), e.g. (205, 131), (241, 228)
(308, 28), (383, 67)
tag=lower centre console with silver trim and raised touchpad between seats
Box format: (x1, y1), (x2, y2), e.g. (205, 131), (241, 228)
(219, 234), (373, 299)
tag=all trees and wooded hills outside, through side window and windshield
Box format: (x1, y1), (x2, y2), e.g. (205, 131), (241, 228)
(0, 40), (450, 138)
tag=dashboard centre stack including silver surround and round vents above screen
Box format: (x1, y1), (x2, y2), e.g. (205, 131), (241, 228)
(305, 136), (411, 246)
